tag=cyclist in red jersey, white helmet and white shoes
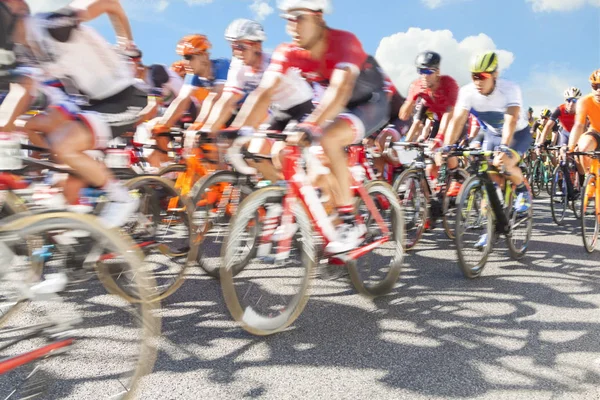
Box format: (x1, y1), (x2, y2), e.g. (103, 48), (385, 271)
(255, 0), (390, 253)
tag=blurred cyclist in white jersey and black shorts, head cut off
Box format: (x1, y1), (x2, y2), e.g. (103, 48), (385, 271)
(0, 0), (146, 226)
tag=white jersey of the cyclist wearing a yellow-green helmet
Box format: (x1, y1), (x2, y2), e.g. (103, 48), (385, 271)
(455, 79), (529, 136)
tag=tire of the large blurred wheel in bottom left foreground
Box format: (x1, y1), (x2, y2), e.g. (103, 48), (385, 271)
(0, 212), (160, 399)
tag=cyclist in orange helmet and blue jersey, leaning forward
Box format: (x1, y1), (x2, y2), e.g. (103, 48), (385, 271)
(148, 34), (229, 167)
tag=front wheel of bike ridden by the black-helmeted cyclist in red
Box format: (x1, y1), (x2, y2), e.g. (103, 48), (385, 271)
(393, 169), (427, 250)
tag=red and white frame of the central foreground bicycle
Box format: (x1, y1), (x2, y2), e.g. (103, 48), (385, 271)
(279, 145), (391, 260)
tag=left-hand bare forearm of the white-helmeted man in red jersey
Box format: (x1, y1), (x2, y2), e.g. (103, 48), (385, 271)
(231, 71), (282, 128)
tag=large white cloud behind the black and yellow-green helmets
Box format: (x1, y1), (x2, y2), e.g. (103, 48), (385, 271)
(375, 28), (514, 95)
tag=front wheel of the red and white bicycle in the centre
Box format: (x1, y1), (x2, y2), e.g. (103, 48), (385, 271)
(220, 187), (317, 335)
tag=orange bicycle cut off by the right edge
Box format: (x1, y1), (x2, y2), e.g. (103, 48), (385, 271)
(571, 151), (600, 253)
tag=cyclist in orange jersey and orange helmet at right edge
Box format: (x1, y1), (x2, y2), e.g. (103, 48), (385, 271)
(569, 69), (600, 171)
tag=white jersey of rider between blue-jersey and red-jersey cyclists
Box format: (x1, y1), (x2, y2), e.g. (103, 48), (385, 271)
(223, 53), (314, 111)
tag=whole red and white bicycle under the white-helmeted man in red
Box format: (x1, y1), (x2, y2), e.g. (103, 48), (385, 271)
(220, 135), (404, 335)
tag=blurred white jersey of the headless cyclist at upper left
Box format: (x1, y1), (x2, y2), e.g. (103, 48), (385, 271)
(26, 13), (135, 100)
